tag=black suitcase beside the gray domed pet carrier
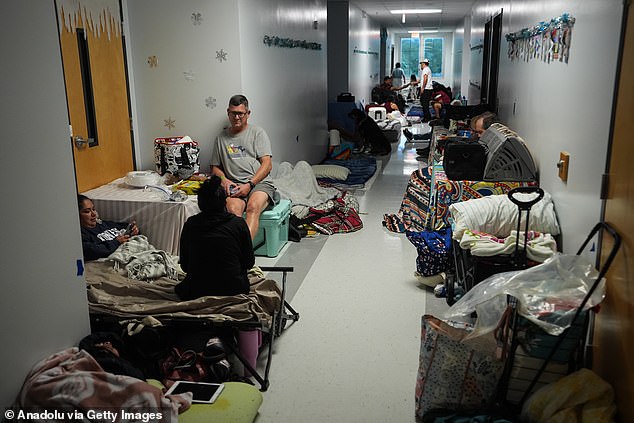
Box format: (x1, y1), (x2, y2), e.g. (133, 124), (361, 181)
(443, 138), (487, 181)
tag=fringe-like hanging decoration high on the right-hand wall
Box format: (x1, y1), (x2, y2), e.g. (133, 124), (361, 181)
(505, 13), (575, 63)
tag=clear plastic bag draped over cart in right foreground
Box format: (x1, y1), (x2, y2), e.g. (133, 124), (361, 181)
(444, 253), (605, 338)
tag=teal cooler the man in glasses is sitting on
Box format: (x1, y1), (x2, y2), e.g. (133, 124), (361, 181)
(253, 199), (291, 257)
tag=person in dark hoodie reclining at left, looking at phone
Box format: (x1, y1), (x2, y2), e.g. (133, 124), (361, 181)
(77, 194), (139, 261)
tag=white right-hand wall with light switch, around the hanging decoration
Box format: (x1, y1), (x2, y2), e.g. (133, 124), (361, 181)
(472, 0), (622, 252)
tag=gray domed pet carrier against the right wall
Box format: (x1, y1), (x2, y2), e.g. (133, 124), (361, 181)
(480, 123), (537, 181)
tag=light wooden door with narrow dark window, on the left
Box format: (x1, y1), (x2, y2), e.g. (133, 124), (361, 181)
(57, 0), (134, 192)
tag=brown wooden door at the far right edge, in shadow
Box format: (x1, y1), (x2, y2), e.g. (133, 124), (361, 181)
(593, 6), (634, 422)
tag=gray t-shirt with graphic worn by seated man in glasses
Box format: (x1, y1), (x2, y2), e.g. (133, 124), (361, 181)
(211, 125), (272, 184)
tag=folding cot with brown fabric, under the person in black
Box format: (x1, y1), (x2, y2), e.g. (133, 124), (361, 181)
(85, 262), (299, 391)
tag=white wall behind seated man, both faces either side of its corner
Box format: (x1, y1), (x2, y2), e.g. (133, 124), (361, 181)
(127, 0), (327, 172)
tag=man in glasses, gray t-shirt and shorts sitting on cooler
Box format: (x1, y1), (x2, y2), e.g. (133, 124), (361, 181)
(211, 95), (275, 239)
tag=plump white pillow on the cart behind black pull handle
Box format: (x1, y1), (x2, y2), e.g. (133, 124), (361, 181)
(449, 192), (559, 240)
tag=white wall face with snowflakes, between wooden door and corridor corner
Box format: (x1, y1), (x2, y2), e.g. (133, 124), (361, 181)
(124, 0), (242, 172)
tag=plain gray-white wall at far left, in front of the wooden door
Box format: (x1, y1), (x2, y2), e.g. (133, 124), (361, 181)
(0, 0), (89, 406)
